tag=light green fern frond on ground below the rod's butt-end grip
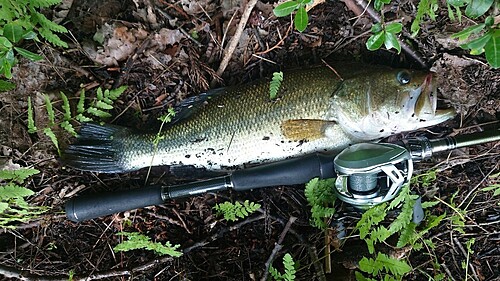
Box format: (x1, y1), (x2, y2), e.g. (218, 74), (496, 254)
(113, 232), (182, 257)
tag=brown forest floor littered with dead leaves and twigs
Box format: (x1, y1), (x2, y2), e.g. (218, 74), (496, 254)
(0, 0), (500, 280)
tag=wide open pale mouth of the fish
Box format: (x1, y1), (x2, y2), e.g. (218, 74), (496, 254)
(410, 73), (456, 126)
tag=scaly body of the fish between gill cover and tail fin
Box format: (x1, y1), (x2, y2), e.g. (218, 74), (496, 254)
(125, 68), (346, 169)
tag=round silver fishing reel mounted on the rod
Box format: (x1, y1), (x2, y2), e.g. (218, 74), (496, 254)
(333, 143), (413, 207)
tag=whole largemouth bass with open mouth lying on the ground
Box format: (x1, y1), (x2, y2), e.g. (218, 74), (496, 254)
(62, 64), (456, 173)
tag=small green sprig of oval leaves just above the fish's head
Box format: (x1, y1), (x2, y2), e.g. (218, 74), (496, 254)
(366, 22), (403, 54)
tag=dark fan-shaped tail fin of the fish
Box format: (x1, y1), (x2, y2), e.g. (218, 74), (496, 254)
(61, 123), (130, 173)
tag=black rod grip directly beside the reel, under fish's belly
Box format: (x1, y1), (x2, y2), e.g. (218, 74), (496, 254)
(231, 153), (336, 191)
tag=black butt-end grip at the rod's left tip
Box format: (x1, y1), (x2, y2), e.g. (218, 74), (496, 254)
(65, 185), (163, 222)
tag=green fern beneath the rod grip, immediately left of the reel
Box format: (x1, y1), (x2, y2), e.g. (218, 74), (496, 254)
(304, 178), (337, 230)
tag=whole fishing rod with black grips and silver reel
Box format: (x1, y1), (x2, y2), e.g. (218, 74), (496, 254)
(65, 128), (500, 222)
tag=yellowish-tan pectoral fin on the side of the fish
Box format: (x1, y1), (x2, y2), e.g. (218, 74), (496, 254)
(281, 119), (335, 141)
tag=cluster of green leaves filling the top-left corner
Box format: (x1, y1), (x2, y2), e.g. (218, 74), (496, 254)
(0, 0), (68, 86)
